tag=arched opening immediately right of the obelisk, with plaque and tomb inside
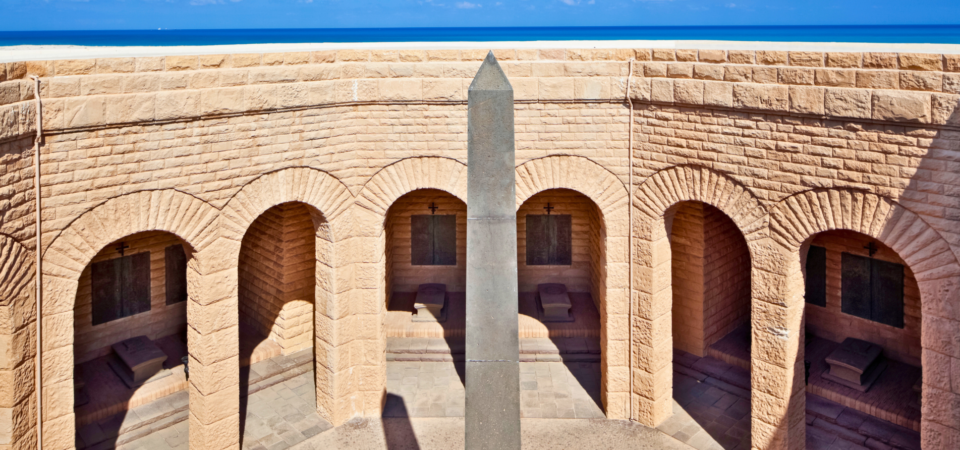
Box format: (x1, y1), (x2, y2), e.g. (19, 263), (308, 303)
(517, 188), (608, 419)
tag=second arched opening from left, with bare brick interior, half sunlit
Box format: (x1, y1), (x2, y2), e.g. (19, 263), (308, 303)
(237, 202), (333, 448)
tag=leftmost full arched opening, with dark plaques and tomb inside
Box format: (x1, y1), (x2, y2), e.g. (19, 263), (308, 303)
(73, 231), (197, 448)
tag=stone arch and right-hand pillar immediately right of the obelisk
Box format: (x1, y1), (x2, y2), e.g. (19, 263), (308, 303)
(516, 155), (630, 419)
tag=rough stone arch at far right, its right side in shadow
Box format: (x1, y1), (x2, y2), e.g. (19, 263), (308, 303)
(766, 189), (960, 447)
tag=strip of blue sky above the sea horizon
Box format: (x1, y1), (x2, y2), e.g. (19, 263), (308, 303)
(0, 0), (960, 31)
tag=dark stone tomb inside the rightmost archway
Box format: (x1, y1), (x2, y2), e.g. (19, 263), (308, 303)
(823, 338), (887, 392)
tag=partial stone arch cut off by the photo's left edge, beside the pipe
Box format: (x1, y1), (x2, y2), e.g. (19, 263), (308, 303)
(0, 234), (37, 446)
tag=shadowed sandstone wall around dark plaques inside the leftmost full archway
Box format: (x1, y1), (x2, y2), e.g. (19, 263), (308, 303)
(73, 231), (189, 364)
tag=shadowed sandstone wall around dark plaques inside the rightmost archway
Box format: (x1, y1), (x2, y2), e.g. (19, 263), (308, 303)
(804, 231), (922, 367)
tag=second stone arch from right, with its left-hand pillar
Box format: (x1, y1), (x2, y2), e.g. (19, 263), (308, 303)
(632, 165), (766, 432)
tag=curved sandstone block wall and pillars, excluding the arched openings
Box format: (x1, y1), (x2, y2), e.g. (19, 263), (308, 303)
(0, 45), (960, 448)
